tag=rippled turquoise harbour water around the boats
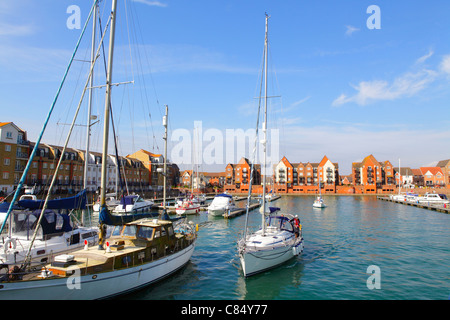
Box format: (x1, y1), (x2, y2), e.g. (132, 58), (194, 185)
(118, 196), (450, 300)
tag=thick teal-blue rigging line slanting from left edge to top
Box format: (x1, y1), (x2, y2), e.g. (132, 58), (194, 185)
(0, 0), (97, 233)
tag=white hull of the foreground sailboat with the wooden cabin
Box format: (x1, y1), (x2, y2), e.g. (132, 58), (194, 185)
(0, 242), (195, 300)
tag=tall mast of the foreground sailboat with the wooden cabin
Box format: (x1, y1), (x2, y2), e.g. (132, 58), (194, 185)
(99, 0), (117, 249)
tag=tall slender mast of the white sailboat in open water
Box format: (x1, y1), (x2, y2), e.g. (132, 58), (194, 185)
(261, 13), (269, 236)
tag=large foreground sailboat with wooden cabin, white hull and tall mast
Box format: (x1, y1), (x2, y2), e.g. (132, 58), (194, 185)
(0, 0), (197, 300)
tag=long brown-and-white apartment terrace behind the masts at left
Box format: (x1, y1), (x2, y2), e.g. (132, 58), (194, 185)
(0, 122), (179, 196)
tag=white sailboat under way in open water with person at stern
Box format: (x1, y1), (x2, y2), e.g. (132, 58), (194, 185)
(238, 14), (303, 277)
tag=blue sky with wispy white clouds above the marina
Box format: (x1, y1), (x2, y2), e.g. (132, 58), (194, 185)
(0, 0), (450, 174)
